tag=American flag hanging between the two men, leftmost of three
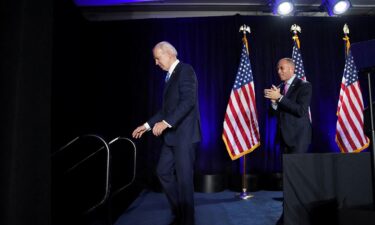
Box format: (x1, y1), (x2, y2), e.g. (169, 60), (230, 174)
(222, 39), (260, 160)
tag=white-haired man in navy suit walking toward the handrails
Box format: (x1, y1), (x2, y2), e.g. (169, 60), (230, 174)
(132, 41), (201, 225)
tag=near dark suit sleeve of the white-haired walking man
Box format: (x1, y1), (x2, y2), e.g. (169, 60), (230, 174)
(164, 66), (198, 127)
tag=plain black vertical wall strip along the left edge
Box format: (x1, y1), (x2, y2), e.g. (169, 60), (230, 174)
(0, 0), (53, 225)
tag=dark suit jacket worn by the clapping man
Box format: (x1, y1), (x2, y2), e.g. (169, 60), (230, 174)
(277, 77), (312, 153)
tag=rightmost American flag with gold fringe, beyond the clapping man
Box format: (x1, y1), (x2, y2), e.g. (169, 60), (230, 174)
(336, 48), (370, 152)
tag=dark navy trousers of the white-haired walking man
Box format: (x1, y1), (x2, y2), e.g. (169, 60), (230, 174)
(157, 143), (196, 225)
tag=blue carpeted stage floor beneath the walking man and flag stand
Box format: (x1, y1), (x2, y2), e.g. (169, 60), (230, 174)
(115, 190), (283, 225)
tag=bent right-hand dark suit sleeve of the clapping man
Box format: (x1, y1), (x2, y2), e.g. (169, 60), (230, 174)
(278, 82), (312, 117)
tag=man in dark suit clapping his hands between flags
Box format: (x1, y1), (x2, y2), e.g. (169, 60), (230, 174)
(264, 58), (312, 153)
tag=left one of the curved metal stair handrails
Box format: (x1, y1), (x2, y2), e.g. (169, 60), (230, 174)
(52, 134), (111, 214)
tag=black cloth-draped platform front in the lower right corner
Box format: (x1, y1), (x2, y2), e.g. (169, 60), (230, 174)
(283, 152), (372, 225)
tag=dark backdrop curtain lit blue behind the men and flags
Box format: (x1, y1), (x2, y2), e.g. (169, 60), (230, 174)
(52, 2), (375, 188)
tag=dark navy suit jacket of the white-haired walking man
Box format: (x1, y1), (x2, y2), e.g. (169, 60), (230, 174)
(147, 62), (201, 146)
